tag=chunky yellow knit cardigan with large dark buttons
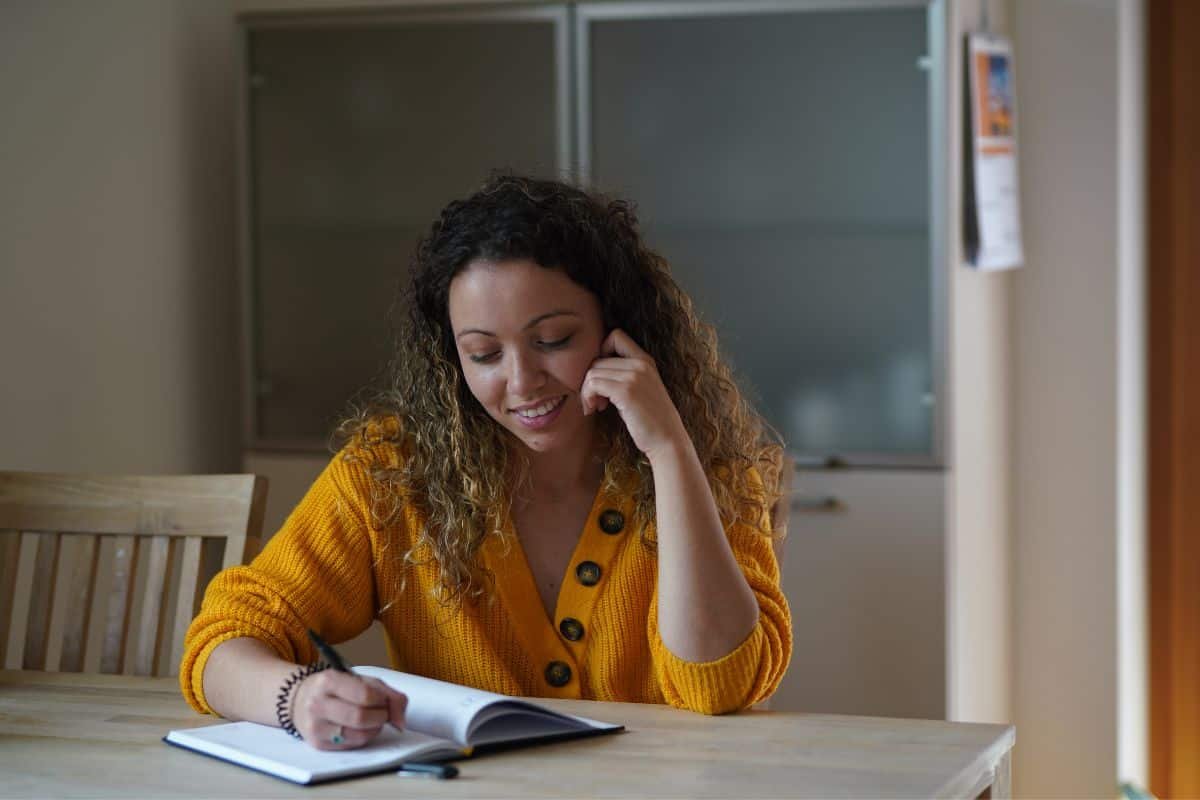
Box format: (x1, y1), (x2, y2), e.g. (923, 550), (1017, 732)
(179, 443), (792, 714)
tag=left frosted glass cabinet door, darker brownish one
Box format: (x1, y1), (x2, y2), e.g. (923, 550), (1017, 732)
(246, 8), (569, 445)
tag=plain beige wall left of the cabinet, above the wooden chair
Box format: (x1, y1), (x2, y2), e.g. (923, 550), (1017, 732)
(0, 0), (238, 473)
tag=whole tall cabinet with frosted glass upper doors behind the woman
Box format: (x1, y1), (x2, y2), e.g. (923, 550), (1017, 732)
(242, 0), (948, 717)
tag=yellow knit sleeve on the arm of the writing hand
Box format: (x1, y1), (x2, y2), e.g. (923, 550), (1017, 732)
(179, 456), (376, 712)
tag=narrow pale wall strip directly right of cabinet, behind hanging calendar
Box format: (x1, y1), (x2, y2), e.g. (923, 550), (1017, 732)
(946, 2), (1020, 741)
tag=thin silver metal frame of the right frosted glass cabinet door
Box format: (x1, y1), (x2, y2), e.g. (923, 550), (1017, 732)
(572, 0), (955, 469)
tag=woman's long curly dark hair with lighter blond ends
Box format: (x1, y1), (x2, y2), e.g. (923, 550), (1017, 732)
(335, 174), (782, 604)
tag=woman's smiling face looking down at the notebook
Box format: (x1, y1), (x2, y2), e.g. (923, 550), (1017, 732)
(449, 259), (605, 452)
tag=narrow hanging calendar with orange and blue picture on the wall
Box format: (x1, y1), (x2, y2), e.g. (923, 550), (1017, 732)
(962, 34), (1025, 270)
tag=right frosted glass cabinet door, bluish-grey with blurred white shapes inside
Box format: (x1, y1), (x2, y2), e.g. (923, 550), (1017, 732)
(576, 2), (937, 463)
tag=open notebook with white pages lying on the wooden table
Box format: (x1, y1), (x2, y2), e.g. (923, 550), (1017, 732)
(163, 667), (623, 783)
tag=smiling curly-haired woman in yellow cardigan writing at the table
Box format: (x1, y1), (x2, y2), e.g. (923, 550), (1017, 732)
(180, 176), (791, 748)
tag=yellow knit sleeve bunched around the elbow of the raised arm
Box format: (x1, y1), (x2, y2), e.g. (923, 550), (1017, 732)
(648, 482), (792, 714)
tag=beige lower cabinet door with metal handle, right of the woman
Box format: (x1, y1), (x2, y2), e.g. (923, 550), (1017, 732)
(772, 469), (947, 720)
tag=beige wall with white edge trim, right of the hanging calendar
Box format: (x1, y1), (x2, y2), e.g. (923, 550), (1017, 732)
(1012, 0), (1145, 796)
